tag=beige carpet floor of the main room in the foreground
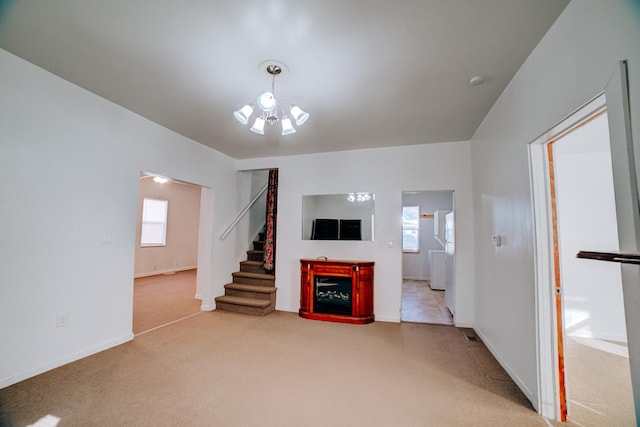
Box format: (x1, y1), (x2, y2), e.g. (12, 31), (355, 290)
(0, 311), (555, 427)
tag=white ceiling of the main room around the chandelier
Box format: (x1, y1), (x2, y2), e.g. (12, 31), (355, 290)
(0, 0), (568, 159)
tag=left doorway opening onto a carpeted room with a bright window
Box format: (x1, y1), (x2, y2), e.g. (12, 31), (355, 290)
(132, 173), (202, 335)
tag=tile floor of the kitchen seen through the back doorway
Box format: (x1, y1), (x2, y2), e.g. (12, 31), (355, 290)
(401, 280), (453, 325)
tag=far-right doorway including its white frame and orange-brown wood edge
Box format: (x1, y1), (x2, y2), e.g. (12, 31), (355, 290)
(529, 70), (637, 425)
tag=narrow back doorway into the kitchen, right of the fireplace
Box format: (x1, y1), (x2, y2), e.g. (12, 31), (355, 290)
(400, 191), (454, 325)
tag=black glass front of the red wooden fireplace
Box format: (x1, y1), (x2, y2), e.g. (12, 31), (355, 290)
(313, 276), (352, 315)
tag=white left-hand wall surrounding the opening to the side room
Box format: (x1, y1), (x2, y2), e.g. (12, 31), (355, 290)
(0, 50), (237, 387)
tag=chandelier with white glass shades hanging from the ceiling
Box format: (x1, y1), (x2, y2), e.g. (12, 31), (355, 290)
(233, 61), (309, 135)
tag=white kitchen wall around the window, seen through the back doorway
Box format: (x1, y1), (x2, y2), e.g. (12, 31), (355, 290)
(402, 191), (453, 280)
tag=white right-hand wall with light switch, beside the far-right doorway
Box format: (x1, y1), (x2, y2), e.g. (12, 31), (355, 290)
(471, 0), (640, 407)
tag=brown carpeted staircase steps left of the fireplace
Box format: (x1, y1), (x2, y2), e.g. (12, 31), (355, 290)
(216, 233), (277, 316)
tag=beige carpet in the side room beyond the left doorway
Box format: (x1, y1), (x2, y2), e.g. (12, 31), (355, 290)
(133, 270), (202, 334)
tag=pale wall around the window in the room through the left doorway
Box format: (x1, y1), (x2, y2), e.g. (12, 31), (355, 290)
(134, 176), (200, 277)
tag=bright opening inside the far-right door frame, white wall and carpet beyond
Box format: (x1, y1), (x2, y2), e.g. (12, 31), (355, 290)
(548, 109), (634, 425)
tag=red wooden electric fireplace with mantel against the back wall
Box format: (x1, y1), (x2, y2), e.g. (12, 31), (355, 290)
(299, 259), (375, 324)
